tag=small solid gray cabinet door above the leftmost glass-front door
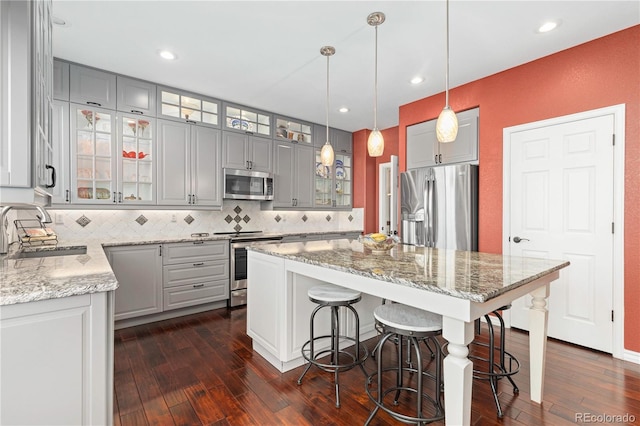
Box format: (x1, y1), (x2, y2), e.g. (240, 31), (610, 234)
(69, 64), (116, 109)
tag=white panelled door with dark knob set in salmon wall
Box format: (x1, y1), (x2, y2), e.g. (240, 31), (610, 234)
(505, 114), (614, 353)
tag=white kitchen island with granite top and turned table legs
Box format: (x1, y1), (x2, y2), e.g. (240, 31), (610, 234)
(247, 240), (569, 425)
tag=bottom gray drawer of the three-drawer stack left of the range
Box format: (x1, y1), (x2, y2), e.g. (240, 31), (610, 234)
(163, 280), (229, 311)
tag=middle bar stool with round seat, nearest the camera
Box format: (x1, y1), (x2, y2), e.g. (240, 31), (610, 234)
(365, 303), (444, 425)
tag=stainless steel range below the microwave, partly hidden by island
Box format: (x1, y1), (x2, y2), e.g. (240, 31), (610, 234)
(214, 231), (282, 307)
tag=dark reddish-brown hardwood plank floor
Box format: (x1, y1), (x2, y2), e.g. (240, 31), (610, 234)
(114, 308), (640, 426)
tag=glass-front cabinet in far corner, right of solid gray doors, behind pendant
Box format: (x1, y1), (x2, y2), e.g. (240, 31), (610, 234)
(314, 150), (353, 208)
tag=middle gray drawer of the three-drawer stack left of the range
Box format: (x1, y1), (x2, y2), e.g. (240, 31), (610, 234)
(162, 261), (229, 288)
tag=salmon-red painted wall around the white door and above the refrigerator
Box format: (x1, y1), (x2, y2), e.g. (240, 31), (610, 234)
(398, 25), (640, 352)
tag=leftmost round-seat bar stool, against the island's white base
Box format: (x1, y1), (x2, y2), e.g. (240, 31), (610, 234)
(298, 284), (369, 407)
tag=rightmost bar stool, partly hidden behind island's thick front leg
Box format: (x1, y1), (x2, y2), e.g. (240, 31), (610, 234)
(469, 304), (520, 418)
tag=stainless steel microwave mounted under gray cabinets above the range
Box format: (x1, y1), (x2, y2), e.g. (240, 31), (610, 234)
(224, 168), (273, 200)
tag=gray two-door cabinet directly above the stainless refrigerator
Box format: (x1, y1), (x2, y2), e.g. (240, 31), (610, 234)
(407, 108), (479, 170)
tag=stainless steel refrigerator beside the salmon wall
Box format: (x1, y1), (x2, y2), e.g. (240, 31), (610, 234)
(400, 164), (478, 251)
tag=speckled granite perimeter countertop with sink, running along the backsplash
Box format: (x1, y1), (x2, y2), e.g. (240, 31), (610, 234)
(0, 230), (359, 306)
